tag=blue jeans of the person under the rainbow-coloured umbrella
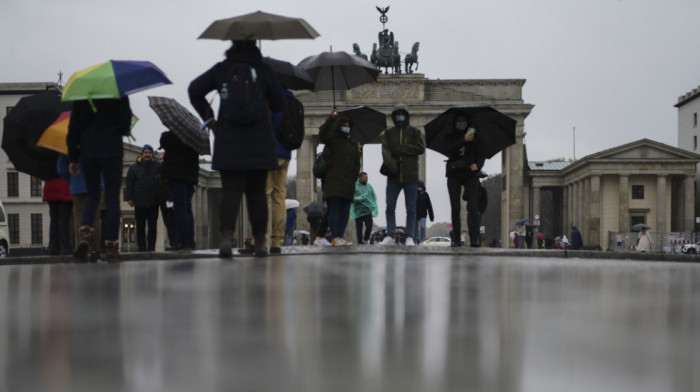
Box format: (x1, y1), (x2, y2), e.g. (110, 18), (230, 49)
(80, 157), (122, 241)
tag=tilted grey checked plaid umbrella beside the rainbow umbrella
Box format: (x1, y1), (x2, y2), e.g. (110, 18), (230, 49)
(148, 97), (211, 155)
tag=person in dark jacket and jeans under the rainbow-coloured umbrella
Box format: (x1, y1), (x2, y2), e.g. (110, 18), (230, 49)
(66, 97), (132, 261)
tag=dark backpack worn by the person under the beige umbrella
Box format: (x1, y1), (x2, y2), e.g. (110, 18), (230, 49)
(219, 63), (268, 125)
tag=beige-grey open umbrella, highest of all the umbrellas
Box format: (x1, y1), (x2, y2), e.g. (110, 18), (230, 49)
(199, 11), (320, 41)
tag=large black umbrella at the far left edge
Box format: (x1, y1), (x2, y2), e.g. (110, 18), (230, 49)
(2, 91), (73, 180)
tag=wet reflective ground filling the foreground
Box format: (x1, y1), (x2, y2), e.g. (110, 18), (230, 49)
(0, 253), (700, 392)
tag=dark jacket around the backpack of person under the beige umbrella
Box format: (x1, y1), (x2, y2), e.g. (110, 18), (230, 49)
(188, 48), (285, 170)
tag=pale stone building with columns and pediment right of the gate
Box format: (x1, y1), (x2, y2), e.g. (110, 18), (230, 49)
(525, 139), (700, 249)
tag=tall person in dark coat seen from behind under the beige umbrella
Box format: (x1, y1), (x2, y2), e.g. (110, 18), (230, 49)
(188, 41), (285, 257)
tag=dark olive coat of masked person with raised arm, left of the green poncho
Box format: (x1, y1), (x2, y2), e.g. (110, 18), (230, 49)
(318, 117), (360, 201)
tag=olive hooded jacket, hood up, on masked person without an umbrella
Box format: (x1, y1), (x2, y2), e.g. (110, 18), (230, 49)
(382, 103), (425, 183)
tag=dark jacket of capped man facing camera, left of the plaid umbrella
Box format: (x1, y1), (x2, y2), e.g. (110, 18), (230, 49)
(126, 155), (161, 208)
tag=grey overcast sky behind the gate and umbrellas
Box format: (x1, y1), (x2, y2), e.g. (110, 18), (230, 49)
(0, 0), (700, 228)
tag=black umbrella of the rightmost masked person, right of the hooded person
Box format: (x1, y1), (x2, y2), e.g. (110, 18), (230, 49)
(425, 105), (516, 158)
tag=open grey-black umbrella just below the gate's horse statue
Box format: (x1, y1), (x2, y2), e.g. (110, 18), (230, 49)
(299, 51), (379, 107)
